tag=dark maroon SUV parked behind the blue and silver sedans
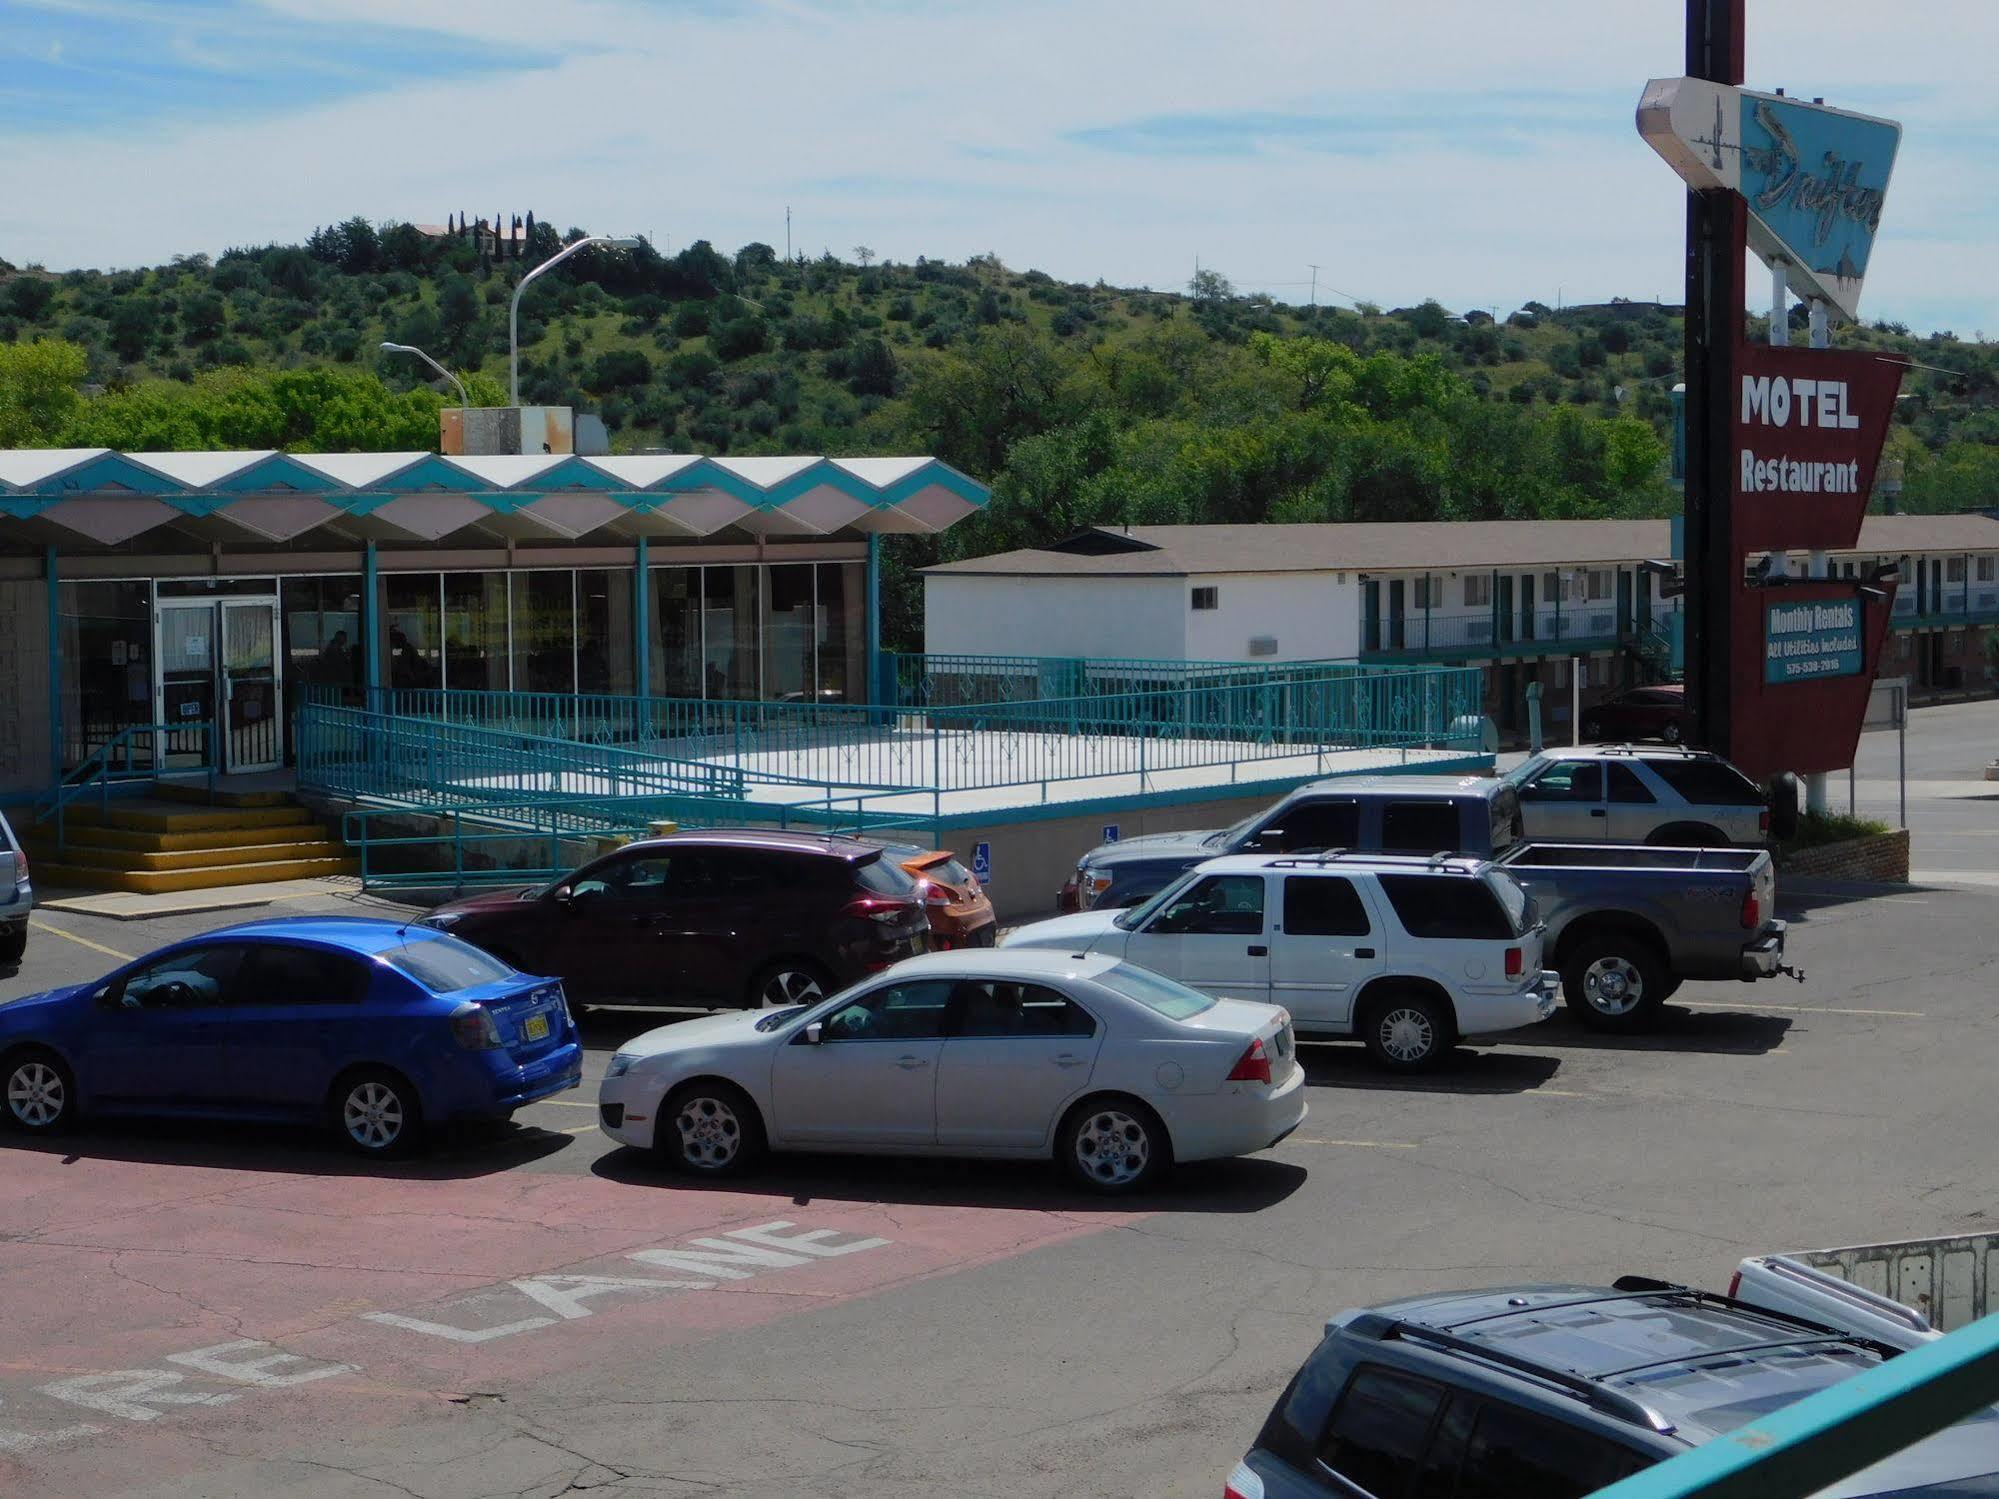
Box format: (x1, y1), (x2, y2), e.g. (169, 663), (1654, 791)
(424, 829), (930, 1007)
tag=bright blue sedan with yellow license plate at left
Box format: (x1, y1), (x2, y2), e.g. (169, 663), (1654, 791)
(0, 917), (584, 1155)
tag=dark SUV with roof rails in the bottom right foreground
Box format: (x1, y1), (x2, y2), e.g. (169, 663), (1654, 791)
(1225, 1277), (1999, 1499)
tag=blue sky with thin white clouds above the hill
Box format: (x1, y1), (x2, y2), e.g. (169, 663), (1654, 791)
(0, 0), (1999, 336)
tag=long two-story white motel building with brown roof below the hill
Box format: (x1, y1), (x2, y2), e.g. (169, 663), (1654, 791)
(924, 514), (1999, 740)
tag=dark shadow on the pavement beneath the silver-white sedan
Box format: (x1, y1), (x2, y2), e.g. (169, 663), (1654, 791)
(590, 1147), (1305, 1213)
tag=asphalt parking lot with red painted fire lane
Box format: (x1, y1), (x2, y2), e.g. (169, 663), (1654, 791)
(0, 723), (1999, 1499)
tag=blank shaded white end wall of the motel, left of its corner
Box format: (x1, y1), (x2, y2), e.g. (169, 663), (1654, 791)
(924, 574), (1187, 662)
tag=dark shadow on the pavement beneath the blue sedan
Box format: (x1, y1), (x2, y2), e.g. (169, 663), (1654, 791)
(0, 1119), (574, 1181)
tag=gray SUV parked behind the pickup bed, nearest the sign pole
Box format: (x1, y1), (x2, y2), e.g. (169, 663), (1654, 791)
(1501, 744), (1787, 847)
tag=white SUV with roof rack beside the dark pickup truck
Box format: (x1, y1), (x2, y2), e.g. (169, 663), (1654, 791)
(1000, 853), (1561, 1071)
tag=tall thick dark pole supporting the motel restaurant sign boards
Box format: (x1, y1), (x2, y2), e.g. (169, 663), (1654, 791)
(1685, 0), (1747, 755)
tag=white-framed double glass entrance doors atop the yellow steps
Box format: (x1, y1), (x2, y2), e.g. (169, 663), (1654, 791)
(154, 598), (284, 771)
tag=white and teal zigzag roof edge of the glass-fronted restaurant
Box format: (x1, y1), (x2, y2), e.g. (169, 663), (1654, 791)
(0, 448), (992, 559)
